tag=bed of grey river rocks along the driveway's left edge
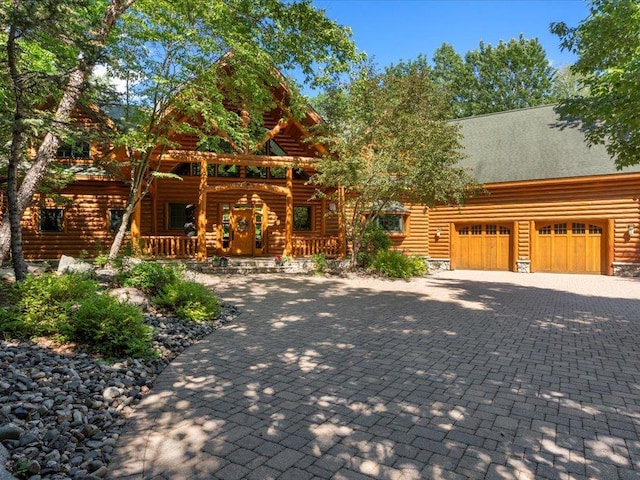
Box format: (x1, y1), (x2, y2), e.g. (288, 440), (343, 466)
(0, 304), (238, 480)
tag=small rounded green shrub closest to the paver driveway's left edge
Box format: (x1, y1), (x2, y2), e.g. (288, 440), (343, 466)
(153, 280), (220, 322)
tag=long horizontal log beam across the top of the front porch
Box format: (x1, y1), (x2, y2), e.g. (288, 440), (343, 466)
(162, 150), (320, 167)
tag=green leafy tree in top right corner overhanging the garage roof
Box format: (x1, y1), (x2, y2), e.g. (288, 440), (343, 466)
(551, 0), (640, 168)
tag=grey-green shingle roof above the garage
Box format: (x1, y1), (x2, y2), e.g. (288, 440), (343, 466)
(458, 105), (640, 183)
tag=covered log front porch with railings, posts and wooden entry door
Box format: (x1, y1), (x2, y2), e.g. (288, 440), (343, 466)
(131, 150), (345, 262)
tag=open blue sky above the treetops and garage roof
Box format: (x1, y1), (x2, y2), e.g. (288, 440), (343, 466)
(313, 0), (589, 67)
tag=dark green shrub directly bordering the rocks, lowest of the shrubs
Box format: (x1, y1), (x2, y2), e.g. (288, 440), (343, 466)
(66, 294), (154, 358)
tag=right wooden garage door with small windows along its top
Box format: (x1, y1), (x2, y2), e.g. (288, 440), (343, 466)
(533, 222), (604, 273)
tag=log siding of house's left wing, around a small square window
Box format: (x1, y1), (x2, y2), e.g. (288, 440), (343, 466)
(22, 181), (128, 260)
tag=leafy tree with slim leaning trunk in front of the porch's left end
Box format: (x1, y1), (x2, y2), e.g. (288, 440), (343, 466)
(100, 0), (359, 260)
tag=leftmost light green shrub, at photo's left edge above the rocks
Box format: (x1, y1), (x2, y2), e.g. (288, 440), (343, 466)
(0, 273), (97, 338)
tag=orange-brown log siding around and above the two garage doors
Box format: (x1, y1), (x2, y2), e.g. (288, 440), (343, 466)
(429, 175), (640, 263)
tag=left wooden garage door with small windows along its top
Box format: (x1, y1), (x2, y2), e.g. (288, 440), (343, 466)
(455, 223), (511, 270)
